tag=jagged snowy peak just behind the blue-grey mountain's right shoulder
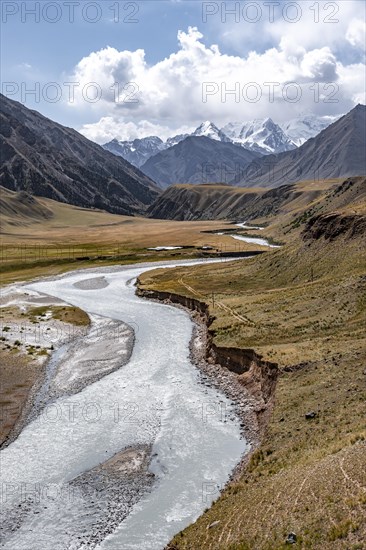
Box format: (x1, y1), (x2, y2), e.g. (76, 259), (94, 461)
(222, 118), (297, 155)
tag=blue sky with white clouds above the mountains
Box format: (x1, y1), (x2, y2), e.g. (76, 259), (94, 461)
(1, 0), (366, 144)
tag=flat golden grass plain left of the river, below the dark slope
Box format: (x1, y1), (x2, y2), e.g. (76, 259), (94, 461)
(0, 194), (261, 284)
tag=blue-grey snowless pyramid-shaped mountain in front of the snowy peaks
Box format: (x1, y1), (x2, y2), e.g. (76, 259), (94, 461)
(141, 136), (258, 189)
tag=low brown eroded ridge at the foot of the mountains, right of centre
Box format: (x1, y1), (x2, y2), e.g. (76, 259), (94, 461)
(147, 176), (366, 221)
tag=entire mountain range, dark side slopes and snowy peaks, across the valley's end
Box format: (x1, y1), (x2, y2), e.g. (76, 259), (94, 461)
(0, 95), (366, 216)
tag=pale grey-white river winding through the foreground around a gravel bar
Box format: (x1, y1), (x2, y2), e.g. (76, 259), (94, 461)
(1, 262), (247, 550)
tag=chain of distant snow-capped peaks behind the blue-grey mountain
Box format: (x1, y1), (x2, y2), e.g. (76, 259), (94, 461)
(103, 114), (339, 168)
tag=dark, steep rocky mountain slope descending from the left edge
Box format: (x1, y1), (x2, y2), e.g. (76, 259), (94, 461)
(0, 95), (159, 215)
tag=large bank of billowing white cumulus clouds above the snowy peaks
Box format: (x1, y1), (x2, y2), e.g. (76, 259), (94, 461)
(70, 19), (365, 143)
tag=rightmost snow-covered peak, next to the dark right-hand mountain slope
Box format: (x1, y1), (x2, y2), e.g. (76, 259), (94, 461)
(280, 113), (343, 147)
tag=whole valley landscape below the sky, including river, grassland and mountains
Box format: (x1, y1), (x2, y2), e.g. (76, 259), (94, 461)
(0, 86), (366, 550)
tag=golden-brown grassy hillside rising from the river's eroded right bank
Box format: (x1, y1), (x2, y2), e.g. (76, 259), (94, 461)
(140, 183), (366, 550)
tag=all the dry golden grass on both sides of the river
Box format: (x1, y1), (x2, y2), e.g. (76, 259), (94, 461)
(3, 181), (366, 550)
